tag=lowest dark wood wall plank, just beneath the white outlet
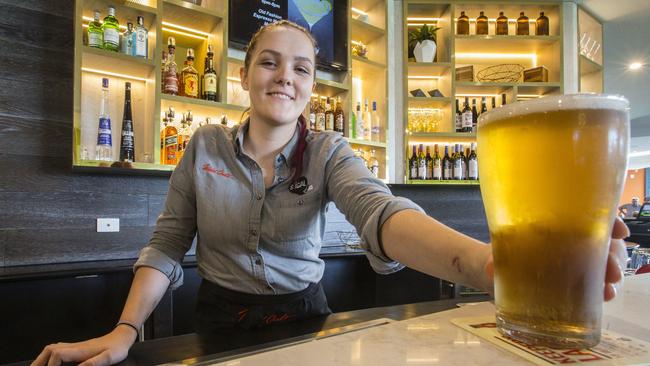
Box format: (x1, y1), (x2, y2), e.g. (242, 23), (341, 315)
(2, 226), (153, 266)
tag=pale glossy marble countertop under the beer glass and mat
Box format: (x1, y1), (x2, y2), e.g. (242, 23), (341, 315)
(158, 274), (650, 366)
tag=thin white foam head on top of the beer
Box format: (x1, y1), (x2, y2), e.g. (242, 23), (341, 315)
(478, 94), (630, 126)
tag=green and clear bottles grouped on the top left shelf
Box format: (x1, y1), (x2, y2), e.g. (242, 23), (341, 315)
(88, 5), (149, 58)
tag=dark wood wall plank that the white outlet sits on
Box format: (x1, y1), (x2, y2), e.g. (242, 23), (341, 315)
(0, 192), (148, 229)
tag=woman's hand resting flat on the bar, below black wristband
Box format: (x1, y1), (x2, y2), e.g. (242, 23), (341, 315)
(31, 326), (137, 366)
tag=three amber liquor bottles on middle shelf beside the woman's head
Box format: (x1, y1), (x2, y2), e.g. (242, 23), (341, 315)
(162, 37), (219, 102)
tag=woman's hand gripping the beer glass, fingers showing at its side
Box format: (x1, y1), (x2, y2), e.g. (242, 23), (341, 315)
(485, 217), (630, 301)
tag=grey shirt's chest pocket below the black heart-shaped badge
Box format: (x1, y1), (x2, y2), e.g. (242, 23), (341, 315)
(273, 192), (322, 242)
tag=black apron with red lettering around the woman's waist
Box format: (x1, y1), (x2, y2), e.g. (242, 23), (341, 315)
(195, 279), (332, 333)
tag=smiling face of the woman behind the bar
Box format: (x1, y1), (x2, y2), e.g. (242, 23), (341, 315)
(240, 27), (315, 126)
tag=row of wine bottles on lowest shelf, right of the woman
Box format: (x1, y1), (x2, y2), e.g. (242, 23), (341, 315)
(408, 143), (478, 180)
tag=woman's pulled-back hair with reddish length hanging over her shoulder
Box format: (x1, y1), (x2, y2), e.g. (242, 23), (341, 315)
(242, 20), (318, 182)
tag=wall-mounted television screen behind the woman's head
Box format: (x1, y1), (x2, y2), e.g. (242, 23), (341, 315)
(228, 0), (348, 70)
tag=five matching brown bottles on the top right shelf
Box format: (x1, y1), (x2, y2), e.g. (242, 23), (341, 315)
(456, 11), (549, 36)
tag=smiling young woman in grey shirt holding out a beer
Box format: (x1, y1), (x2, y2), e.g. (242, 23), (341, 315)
(33, 21), (628, 365)
